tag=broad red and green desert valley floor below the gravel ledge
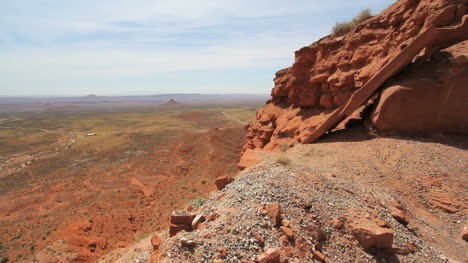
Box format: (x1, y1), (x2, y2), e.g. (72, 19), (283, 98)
(0, 104), (256, 262)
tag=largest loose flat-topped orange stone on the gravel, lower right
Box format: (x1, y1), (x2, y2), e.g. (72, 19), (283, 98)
(351, 222), (394, 250)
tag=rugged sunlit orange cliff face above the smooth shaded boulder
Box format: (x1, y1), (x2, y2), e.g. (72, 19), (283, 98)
(243, 0), (468, 154)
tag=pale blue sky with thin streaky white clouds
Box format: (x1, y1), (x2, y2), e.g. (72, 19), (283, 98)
(0, 0), (394, 96)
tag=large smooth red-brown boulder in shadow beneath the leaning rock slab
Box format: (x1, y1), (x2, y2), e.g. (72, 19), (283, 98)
(371, 41), (468, 133)
